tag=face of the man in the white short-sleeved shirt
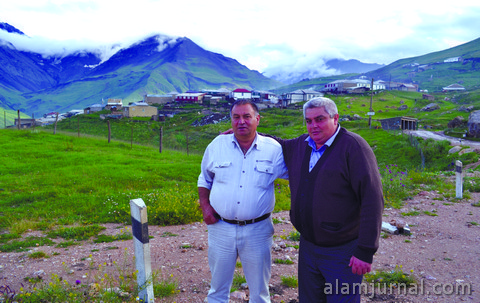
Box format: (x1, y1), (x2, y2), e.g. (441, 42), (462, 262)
(232, 104), (260, 139)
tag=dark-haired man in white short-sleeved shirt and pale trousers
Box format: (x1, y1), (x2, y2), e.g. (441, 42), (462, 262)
(198, 100), (287, 303)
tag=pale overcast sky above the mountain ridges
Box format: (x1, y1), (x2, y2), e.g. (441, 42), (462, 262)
(0, 0), (480, 76)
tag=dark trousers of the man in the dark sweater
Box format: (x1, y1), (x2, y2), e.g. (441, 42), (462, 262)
(298, 237), (363, 303)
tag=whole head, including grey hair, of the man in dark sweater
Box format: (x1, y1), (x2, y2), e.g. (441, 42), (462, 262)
(303, 97), (338, 148)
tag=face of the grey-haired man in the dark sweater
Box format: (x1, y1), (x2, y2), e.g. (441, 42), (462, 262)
(305, 107), (338, 148)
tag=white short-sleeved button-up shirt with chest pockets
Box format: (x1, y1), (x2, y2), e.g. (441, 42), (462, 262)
(197, 134), (288, 220)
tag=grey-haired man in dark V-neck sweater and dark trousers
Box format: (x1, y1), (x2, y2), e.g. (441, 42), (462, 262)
(279, 97), (384, 303)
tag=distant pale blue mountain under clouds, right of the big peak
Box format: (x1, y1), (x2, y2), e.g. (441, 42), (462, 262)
(265, 58), (385, 85)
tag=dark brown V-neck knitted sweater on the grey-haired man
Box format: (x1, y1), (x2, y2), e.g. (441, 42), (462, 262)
(279, 128), (384, 263)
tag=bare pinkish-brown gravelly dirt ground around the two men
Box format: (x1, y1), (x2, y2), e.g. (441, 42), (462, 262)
(0, 185), (480, 303)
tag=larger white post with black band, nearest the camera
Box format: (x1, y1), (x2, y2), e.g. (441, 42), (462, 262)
(130, 199), (155, 303)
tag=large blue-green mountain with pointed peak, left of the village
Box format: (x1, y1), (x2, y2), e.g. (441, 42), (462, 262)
(0, 23), (281, 117)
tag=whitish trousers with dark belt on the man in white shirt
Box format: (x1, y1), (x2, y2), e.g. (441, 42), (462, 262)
(207, 218), (274, 303)
